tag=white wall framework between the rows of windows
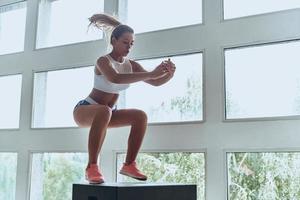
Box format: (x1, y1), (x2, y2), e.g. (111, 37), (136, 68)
(0, 0), (300, 200)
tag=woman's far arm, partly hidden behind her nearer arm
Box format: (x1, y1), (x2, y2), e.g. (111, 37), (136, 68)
(130, 61), (175, 86)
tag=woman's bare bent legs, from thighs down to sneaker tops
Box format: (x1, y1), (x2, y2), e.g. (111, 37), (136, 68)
(74, 105), (147, 164)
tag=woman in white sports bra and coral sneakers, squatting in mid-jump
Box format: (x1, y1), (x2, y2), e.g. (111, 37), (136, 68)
(73, 14), (175, 183)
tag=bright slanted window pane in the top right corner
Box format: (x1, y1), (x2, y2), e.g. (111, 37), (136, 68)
(224, 0), (300, 19)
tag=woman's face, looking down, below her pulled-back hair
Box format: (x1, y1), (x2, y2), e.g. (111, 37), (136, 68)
(112, 32), (134, 56)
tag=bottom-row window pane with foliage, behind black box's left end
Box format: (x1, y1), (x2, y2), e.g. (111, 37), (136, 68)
(30, 153), (88, 200)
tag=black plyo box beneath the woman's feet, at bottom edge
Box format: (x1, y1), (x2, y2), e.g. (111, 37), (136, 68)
(72, 183), (197, 200)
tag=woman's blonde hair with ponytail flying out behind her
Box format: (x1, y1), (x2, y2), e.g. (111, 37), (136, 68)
(89, 14), (134, 42)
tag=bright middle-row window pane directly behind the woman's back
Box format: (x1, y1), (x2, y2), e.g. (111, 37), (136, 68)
(32, 67), (94, 128)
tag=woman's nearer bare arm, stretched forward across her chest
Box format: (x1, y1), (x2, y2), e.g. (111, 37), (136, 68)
(97, 57), (166, 84)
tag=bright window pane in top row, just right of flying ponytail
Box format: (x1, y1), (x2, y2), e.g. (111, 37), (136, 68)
(120, 0), (202, 33)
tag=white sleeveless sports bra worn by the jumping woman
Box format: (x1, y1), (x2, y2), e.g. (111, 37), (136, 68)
(94, 55), (132, 94)
